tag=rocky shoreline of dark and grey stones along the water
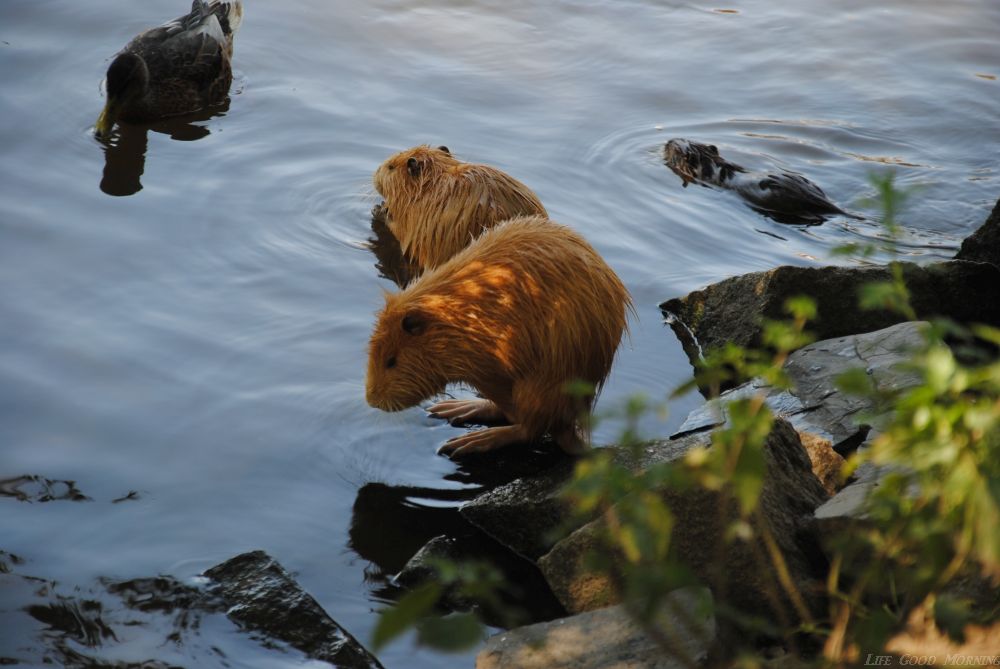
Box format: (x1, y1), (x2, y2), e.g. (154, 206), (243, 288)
(0, 197), (1000, 669)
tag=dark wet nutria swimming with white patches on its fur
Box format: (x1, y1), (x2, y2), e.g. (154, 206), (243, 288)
(663, 139), (861, 224)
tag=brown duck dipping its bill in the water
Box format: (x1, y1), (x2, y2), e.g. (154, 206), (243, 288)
(95, 0), (243, 139)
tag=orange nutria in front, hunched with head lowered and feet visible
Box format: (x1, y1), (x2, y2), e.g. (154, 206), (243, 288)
(366, 216), (634, 457)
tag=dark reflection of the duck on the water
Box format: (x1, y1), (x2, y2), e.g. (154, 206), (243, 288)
(100, 98), (229, 197)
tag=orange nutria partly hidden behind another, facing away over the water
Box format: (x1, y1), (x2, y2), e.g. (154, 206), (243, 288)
(373, 145), (548, 269)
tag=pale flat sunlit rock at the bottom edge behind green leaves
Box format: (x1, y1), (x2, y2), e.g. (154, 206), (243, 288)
(476, 588), (715, 669)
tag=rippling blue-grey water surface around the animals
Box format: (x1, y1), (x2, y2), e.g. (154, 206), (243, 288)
(0, 0), (1000, 668)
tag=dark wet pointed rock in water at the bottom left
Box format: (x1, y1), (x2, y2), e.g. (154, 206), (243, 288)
(205, 551), (382, 669)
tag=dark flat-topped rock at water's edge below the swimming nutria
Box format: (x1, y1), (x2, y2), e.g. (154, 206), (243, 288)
(660, 260), (1000, 378)
